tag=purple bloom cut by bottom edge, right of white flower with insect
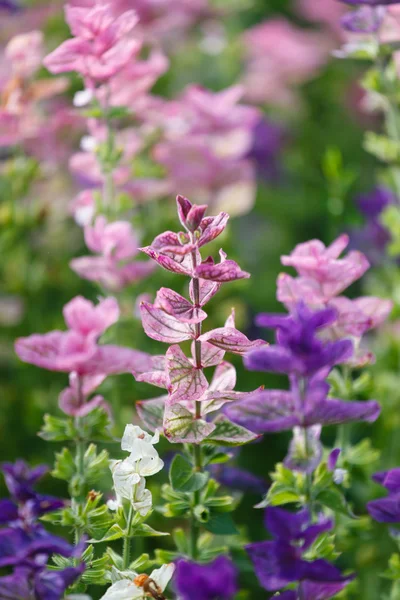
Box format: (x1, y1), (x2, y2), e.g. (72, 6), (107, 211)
(175, 556), (238, 600)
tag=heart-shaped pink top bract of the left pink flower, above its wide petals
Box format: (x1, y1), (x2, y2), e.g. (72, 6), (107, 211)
(63, 296), (120, 338)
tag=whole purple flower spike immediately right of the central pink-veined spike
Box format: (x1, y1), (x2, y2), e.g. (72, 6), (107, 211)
(224, 303), (380, 472)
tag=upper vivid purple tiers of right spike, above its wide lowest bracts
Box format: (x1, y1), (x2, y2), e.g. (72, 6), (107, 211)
(244, 303), (353, 377)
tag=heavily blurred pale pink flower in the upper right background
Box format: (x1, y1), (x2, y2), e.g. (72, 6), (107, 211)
(243, 18), (332, 105)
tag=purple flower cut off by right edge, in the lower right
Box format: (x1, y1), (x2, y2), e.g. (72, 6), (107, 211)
(367, 468), (400, 523)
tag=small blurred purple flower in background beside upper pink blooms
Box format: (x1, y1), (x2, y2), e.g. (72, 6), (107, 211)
(246, 119), (284, 180)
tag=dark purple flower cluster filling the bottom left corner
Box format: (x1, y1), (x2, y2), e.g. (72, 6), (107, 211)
(0, 461), (84, 600)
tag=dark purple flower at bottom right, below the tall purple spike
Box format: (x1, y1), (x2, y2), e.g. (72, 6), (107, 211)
(246, 508), (351, 600)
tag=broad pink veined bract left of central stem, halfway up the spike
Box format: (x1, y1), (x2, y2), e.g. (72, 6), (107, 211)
(140, 302), (194, 344)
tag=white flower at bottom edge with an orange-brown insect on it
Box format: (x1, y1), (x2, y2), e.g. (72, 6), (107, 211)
(101, 563), (175, 600)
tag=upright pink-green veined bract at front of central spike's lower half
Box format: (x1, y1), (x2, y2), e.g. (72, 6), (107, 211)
(166, 345), (208, 402)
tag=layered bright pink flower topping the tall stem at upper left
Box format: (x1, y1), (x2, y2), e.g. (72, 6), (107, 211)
(44, 4), (141, 84)
